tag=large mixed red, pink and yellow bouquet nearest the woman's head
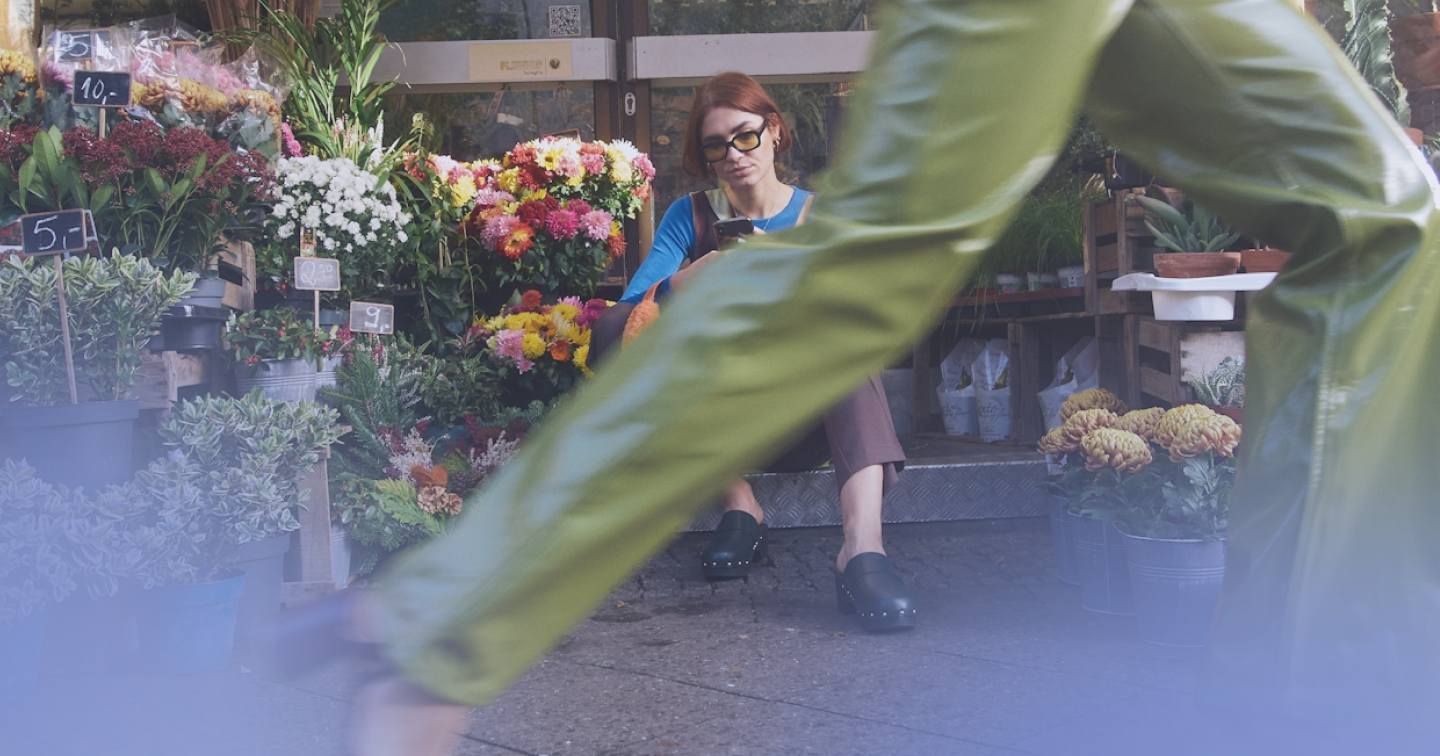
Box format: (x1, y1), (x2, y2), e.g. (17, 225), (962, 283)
(462, 137), (655, 297)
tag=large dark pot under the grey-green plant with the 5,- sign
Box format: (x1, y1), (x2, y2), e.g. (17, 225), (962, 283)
(0, 399), (140, 491)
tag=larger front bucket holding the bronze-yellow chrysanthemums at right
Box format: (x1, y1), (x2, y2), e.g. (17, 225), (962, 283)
(1125, 534), (1225, 647)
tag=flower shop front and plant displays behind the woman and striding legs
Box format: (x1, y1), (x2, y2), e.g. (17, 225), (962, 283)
(0, 0), (1440, 688)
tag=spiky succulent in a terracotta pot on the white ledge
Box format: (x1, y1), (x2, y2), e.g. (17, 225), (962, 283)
(1135, 196), (1240, 278)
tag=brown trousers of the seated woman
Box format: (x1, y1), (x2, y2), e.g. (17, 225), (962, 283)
(588, 302), (904, 491)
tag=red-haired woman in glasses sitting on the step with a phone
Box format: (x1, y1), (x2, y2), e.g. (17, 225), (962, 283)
(590, 72), (916, 632)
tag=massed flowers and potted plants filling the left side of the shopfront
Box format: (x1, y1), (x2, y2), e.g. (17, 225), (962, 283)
(0, 0), (655, 700)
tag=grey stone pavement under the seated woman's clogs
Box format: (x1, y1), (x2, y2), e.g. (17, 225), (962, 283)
(0, 518), (1393, 756)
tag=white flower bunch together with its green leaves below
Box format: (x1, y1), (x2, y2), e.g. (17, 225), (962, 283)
(255, 156), (410, 298)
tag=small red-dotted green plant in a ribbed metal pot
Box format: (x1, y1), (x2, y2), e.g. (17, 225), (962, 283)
(225, 307), (330, 402)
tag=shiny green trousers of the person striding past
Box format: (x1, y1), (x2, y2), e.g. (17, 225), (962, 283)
(379, 0), (1440, 720)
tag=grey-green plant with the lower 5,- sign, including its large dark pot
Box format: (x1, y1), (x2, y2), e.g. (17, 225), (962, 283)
(0, 255), (194, 491)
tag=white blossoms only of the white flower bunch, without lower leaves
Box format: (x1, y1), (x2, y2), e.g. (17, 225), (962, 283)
(272, 156), (410, 256)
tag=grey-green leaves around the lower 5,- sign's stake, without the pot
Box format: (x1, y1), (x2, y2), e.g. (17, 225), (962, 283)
(0, 253), (194, 406)
